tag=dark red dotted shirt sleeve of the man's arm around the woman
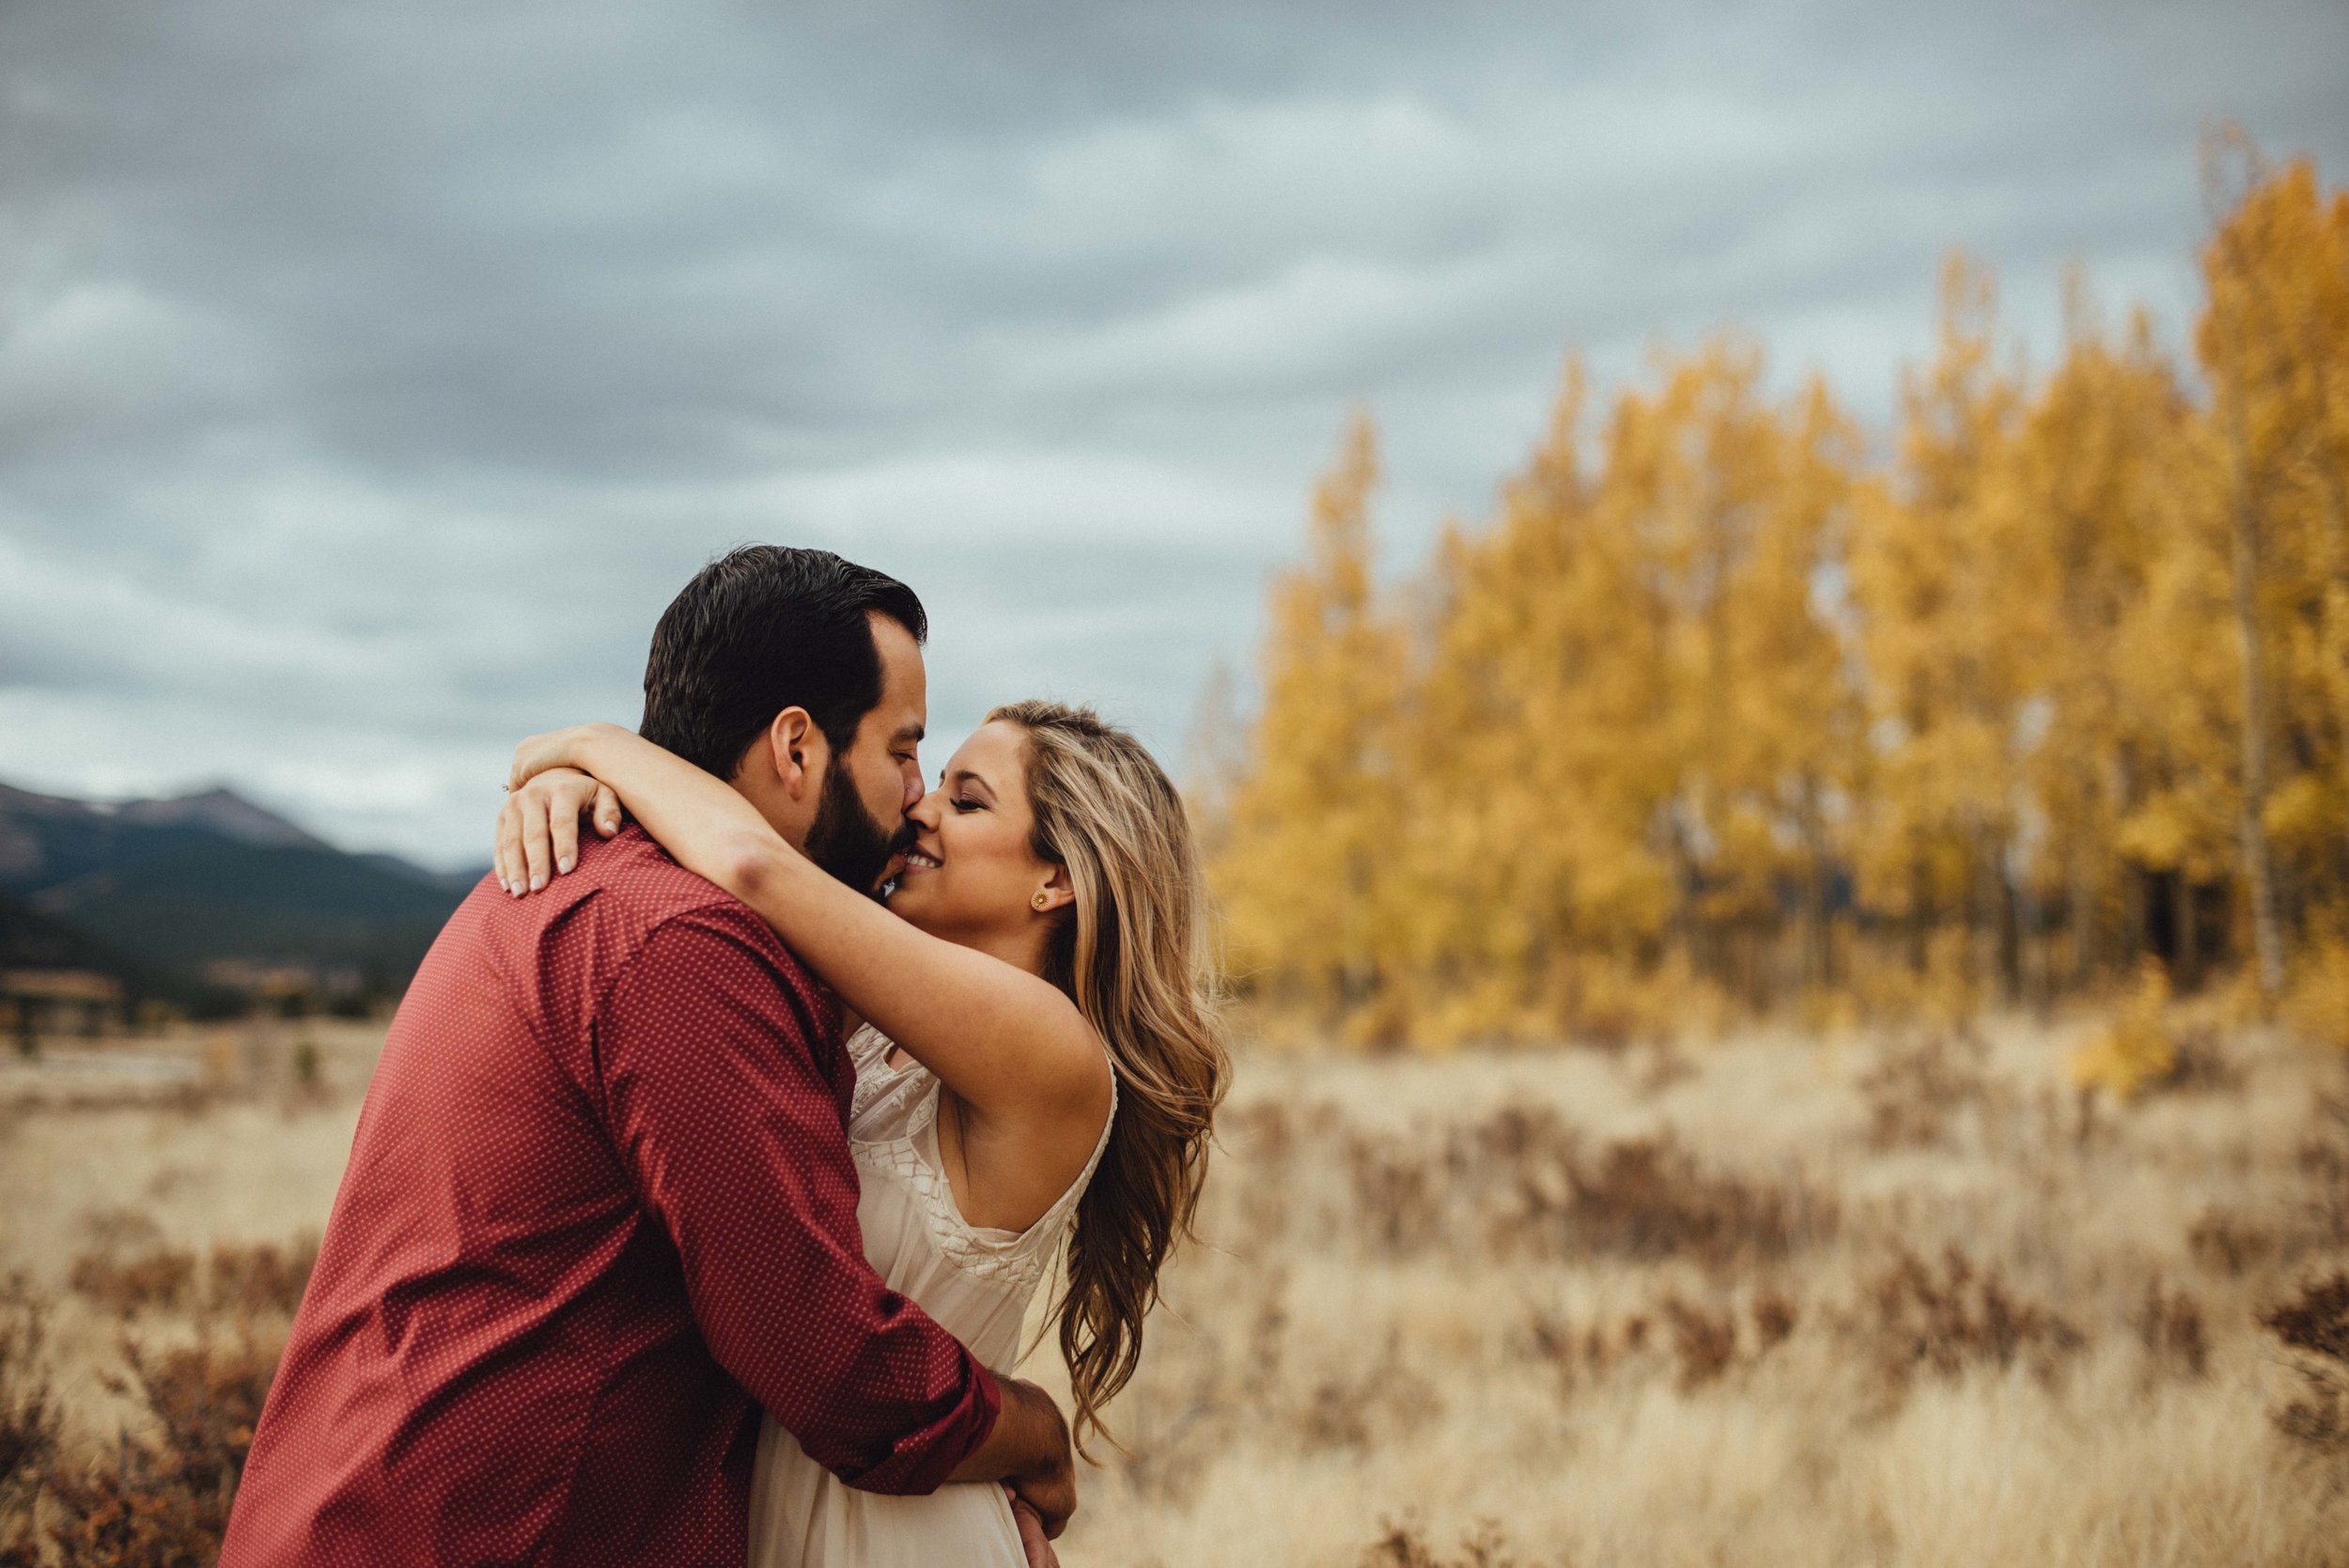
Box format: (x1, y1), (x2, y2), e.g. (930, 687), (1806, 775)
(595, 910), (1001, 1493)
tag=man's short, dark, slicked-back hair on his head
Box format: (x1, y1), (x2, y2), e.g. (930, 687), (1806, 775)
(637, 545), (930, 780)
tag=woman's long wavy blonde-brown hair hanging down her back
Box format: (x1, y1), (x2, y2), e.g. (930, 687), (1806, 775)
(987, 702), (1231, 1453)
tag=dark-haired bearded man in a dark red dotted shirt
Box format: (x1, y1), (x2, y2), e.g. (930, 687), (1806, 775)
(221, 547), (1074, 1568)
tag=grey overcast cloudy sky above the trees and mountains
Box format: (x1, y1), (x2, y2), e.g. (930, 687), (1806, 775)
(0, 0), (2349, 863)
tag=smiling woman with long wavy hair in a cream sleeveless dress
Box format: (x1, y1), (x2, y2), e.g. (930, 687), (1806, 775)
(496, 702), (1229, 1568)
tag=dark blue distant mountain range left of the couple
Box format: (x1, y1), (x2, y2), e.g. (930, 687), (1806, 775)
(0, 784), (479, 1007)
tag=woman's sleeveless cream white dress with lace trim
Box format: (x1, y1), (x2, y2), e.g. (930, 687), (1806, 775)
(750, 1028), (1118, 1568)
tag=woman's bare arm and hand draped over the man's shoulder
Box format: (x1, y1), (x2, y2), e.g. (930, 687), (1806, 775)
(498, 725), (1109, 1125)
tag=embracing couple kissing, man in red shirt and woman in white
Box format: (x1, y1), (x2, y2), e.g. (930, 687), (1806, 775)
(221, 545), (1229, 1568)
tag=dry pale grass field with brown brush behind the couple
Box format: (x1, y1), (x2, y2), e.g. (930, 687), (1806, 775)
(0, 1021), (2349, 1568)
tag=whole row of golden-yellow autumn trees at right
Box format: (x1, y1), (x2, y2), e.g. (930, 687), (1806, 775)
(1206, 133), (2349, 1042)
